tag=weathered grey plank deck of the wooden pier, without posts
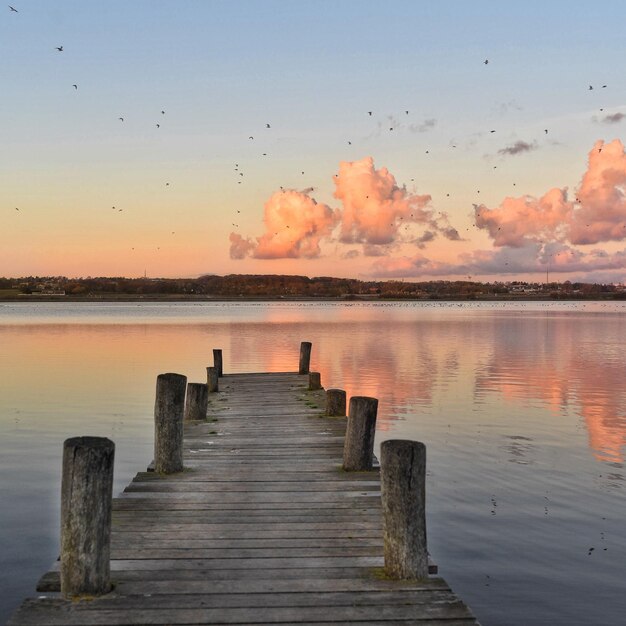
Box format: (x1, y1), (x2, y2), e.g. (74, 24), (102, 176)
(9, 366), (478, 626)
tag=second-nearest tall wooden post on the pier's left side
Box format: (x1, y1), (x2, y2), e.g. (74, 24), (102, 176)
(154, 374), (187, 474)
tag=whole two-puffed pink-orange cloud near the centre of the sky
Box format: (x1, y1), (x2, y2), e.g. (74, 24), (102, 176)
(230, 157), (460, 259)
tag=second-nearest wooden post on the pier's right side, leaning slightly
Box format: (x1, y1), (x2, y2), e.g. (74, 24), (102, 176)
(343, 396), (378, 472)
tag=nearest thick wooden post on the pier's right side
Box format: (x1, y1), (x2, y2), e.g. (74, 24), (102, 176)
(380, 439), (428, 579)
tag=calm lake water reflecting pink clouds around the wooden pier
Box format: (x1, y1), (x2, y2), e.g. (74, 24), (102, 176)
(0, 302), (626, 626)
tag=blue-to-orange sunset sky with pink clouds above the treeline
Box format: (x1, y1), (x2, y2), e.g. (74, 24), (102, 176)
(0, 0), (626, 282)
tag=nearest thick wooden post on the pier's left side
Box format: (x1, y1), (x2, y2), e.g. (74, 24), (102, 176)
(61, 437), (115, 597)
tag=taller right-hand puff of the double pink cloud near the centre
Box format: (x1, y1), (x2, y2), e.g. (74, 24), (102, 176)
(334, 157), (433, 245)
